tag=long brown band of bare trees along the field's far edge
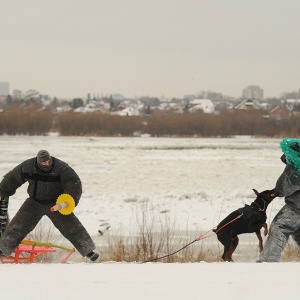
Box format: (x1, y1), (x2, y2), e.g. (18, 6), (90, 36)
(0, 107), (300, 137)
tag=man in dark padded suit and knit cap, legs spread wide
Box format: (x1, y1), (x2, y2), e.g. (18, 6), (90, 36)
(0, 150), (99, 261)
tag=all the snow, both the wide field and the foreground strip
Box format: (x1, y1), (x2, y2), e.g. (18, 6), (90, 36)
(0, 136), (300, 300)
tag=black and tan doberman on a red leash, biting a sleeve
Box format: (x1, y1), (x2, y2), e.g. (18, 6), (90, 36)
(213, 189), (276, 261)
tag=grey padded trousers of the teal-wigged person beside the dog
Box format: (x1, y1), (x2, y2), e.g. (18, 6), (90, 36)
(259, 205), (300, 262)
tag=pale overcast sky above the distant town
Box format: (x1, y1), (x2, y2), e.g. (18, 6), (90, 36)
(0, 0), (300, 98)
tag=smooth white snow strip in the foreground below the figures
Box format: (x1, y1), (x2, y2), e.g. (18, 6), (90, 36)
(0, 263), (300, 300)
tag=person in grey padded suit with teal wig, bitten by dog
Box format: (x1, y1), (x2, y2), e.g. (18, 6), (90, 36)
(258, 138), (300, 262)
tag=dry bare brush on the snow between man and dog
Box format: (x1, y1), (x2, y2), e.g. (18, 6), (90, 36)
(97, 204), (218, 263)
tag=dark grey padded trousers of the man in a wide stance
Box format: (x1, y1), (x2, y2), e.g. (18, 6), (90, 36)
(0, 198), (96, 256)
